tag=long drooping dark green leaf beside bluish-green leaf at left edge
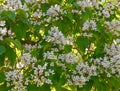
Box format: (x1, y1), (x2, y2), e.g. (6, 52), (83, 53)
(5, 45), (16, 66)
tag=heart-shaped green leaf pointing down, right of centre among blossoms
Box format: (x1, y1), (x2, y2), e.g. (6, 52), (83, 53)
(76, 36), (90, 52)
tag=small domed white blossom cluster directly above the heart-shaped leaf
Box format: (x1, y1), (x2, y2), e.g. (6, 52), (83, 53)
(82, 20), (96, 31)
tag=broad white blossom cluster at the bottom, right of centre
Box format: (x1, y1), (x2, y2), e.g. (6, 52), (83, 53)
(66, 62), (97, 87)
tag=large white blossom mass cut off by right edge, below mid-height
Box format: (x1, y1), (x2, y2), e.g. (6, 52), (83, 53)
(93, 39), (120, 77)
